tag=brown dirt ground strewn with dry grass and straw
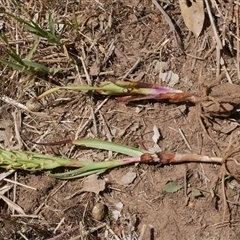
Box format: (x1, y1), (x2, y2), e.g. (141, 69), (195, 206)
(0, 0), (240, 240)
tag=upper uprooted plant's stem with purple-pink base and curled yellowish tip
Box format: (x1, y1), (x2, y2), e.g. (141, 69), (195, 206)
(37, 80), (198, 103)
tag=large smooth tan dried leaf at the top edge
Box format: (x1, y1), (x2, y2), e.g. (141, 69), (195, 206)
(179, 0), (204, 37)
